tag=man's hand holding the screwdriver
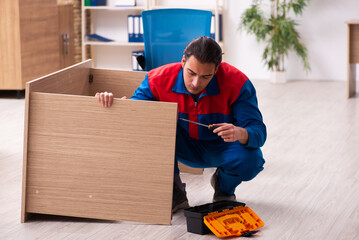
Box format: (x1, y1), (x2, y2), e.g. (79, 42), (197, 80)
(213, 123), (248, 144)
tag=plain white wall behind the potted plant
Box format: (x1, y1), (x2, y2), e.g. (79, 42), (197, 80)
(224, 0), (359, 81)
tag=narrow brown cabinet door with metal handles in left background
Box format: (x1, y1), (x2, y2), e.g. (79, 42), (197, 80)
(58, 4), (74, 68)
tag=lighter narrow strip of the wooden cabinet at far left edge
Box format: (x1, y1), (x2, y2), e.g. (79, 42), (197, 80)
(0, 0), (22, 90)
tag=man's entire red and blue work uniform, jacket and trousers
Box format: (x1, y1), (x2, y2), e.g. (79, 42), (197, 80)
(131, 62), (267, 195)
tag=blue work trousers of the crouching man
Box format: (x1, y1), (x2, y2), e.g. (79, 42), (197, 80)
(175, 126), (264, 195)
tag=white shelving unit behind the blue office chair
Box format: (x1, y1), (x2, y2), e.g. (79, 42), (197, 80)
(81, 0), (224, 70)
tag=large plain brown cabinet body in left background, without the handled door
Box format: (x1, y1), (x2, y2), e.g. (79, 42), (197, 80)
(0, 0), (60, 90)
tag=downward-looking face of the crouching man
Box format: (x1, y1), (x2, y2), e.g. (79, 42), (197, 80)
(182, 56), (218, 97)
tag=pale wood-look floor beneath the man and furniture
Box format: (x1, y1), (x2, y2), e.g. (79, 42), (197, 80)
(0, 81), (359, 240)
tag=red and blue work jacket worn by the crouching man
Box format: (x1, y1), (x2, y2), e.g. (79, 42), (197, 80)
(131, 62), (266, 147)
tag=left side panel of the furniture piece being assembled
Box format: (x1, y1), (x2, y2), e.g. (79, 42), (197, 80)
(21, 60), (91, 222)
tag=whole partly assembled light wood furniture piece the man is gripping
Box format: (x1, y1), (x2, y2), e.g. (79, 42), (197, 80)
(21, 60), (177, 224)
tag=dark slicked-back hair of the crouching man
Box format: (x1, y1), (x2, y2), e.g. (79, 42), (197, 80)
(183, 36), (222, 67)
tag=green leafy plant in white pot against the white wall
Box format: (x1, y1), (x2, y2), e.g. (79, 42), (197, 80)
(240, 0), (310, 83)
